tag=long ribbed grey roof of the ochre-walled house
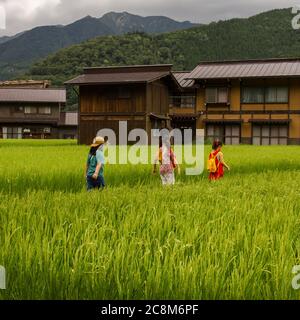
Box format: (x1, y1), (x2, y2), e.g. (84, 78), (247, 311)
(187, 59), (300, 80)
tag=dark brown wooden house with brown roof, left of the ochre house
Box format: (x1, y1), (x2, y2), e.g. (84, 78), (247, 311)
(65, 65), (180, 144)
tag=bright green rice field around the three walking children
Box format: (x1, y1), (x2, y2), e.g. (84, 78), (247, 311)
(0, 140), (300, 299)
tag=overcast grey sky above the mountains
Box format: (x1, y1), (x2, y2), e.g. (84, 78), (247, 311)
(0, 0), (300, 36)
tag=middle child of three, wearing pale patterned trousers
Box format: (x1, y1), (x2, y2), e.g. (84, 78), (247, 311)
(153, 137), (180, 186)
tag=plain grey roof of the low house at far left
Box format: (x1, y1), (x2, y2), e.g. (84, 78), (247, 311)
(0, 88), (66, 103)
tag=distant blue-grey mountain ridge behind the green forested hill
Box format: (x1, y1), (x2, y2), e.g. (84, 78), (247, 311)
(0, 12), (195, 80)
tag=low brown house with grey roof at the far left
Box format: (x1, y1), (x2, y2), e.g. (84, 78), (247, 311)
(0, 86), (72, 139)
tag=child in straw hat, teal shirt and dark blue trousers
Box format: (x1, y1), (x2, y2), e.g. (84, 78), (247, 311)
(86, 137), (105, 191)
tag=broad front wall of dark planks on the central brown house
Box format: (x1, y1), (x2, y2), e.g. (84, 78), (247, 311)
(79, 84), (146, 144)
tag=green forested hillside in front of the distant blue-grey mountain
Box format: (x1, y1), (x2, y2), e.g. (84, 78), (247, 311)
(28, 9), (300, 107)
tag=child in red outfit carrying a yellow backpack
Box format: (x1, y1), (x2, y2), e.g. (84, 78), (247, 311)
(209, 140), (230, 181)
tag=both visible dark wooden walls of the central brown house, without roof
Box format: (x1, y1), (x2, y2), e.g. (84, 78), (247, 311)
(79, 80), (169, 144)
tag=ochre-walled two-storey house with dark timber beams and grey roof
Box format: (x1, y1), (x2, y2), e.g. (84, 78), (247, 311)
(186, 59), (300, 145)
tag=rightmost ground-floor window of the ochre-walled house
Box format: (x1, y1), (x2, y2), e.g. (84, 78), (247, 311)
(253, 125), (288, 146)
